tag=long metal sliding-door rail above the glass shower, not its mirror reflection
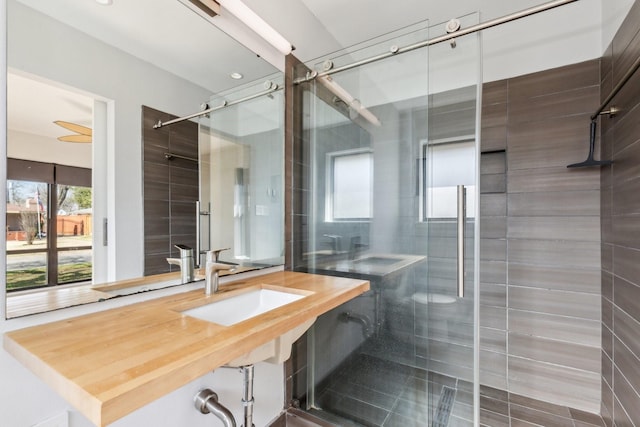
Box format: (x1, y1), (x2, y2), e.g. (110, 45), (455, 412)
(293, 0), (578, 84)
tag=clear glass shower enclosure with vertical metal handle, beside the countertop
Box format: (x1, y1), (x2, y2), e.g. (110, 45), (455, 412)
(293, 14), (481, 427)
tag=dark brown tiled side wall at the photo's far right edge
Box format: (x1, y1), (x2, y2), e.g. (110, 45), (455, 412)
(600, 2), (640, 427)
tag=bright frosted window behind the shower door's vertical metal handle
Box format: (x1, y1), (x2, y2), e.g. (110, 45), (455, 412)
(421, 138), (476, 220)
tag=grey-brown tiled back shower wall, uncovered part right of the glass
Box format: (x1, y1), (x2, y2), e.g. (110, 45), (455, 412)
(480, 60), (600, 412)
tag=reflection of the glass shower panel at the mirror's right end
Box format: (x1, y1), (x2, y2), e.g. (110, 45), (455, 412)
(197, 79), (284, 268)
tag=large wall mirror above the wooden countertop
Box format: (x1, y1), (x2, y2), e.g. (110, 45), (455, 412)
(5, 0), (284, 318)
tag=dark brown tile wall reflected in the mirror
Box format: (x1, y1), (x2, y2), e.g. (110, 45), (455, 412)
(142, 106), (199, 276)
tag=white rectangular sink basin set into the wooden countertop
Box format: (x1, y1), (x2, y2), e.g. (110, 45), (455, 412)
(182, 289), (304, 326)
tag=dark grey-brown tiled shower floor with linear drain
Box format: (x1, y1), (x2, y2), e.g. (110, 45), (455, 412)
(302, 354), (605, 427)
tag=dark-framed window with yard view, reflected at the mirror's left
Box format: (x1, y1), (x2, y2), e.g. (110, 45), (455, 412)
(6, 159), (92, 291)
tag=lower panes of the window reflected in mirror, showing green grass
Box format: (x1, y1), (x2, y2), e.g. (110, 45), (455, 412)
(7, 262), (91, 291)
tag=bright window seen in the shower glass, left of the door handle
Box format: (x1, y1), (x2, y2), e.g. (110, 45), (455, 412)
(325, 149), (373, 221)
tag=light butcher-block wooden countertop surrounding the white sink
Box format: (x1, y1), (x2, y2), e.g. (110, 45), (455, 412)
(4, 271), (369, 426)
